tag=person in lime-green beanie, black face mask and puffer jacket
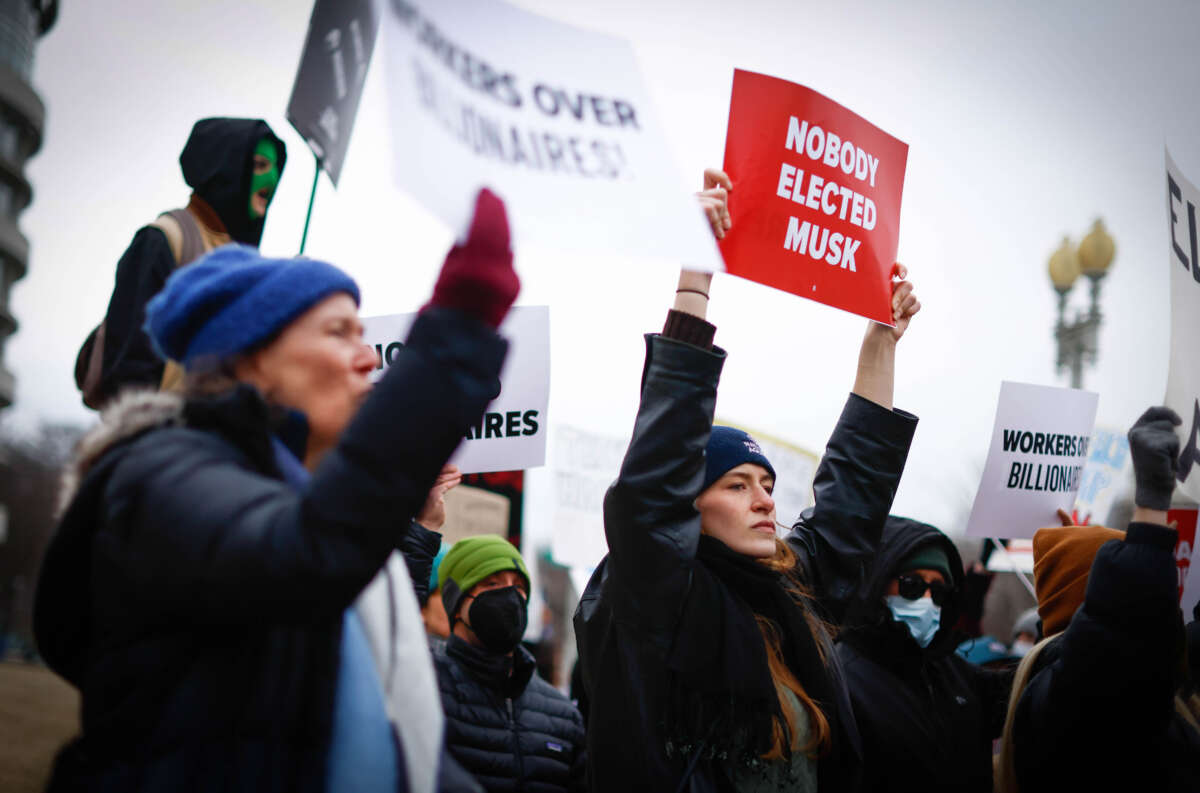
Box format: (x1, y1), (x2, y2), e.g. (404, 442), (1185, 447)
(432, 534), (586, 793)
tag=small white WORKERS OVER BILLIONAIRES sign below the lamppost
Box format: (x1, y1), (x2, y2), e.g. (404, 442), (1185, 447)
(967, 382), (1099, 537)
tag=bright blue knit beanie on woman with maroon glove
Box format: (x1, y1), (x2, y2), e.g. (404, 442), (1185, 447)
(145, 245), (359, 367)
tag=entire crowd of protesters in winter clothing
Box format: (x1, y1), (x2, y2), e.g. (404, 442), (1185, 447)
(28, 119), (1200, 793)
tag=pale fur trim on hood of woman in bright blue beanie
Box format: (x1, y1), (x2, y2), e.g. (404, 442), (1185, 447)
(56, 389), (184, 517)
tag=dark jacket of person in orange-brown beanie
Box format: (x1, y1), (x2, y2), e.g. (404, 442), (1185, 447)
(1012, 523), (1200, 793)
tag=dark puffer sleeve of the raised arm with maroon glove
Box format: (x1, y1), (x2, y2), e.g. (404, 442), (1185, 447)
(97, 308), (506, 624)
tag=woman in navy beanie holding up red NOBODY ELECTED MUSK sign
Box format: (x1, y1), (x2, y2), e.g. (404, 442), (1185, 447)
(575, 172), (920, 791)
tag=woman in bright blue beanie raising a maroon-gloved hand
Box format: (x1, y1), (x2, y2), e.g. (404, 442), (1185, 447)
(34, 190), (520, 793)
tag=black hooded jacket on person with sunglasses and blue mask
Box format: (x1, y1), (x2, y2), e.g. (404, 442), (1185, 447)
(838, 517), (1012, 793)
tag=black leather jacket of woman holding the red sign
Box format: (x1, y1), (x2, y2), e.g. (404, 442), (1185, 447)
(575, 335), (917, 792)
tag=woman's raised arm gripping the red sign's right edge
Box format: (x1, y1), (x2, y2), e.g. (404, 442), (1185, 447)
(787, 264), (920, 621)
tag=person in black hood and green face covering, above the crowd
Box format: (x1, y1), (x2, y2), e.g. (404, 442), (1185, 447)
(84, 118), (287, 409)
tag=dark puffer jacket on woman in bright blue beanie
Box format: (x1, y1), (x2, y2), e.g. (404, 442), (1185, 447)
(34, 310), (506, 793)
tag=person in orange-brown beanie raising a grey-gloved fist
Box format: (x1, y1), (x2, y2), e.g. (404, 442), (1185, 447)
(996, 407), (1200, 793)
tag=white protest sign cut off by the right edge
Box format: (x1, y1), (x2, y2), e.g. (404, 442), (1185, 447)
(1165, 152), (1200, 500)
